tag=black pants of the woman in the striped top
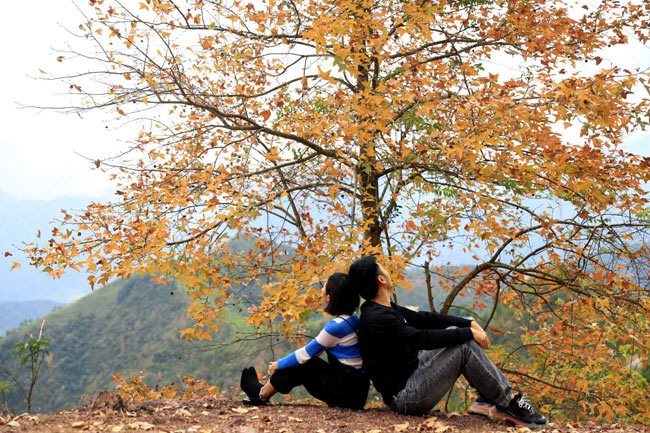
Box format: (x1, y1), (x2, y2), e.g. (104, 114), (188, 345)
(271, 358), (370, 409)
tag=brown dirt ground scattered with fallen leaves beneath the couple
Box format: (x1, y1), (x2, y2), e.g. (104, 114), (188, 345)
(0, 393), (650, 433)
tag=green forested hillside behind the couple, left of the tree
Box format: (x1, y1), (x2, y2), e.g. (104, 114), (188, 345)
(0, 276), (298, 413)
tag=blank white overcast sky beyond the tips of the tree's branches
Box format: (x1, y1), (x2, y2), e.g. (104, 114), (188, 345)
(0, 0), (650, 199)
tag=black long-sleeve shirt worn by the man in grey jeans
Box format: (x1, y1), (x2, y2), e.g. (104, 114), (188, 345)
(358, 301), (473, 405)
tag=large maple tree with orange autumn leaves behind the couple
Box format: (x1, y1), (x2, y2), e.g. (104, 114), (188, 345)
(20, 0), (650, 420)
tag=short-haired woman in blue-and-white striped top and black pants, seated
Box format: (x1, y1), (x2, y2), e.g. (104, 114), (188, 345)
(241, 272), (370, 409)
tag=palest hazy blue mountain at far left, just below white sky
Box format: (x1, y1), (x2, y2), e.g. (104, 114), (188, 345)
(0, 192), (97, 303)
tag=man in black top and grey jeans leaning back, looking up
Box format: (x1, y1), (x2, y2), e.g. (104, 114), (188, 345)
(348, 256), (548, 428)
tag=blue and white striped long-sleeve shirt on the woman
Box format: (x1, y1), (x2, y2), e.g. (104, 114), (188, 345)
(278, 313), (362, 369)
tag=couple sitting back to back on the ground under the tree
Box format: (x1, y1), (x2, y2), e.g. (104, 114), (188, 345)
(241, 256), (548, 429)
